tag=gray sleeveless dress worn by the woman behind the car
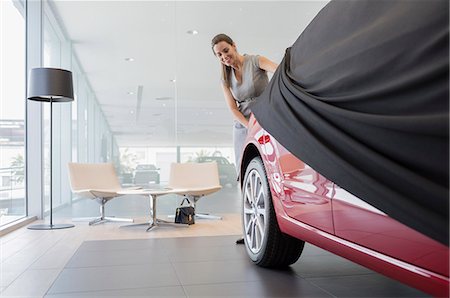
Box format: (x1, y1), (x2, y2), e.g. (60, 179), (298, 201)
(230, 54), (269, 169)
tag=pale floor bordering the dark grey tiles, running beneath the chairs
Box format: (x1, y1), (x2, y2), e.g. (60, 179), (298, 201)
(0, 214), (241, 297)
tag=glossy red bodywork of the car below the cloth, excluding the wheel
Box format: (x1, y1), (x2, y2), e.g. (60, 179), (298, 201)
(240, 116), (449, 296)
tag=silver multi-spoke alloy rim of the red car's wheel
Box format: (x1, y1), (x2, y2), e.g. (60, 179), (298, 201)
(243, 169), (266, 254)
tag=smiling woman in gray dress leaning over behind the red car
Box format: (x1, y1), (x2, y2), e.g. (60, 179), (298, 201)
(211, 34), (278, 244)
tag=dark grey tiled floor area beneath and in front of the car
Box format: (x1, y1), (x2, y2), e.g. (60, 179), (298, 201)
(46, 236), (424, 297)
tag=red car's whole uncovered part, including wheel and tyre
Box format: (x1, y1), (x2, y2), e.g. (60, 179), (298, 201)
(240, 116), (449, 296)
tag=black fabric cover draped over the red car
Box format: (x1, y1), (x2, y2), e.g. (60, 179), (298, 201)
(251, 0), (449, 245)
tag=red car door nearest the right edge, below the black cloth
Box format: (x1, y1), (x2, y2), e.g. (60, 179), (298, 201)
(332, 184), (449, 276)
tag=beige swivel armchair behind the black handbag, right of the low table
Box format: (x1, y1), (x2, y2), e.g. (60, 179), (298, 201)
(168, 162), (222, 219)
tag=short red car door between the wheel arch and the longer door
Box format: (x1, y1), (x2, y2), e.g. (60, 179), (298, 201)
(264, 133), (334, 233)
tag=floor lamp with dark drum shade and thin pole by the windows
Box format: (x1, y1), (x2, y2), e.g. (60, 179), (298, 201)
(28, 68), (74, 230)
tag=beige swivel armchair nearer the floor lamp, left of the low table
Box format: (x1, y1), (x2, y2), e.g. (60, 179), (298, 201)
(68, 163), (133, 225)
